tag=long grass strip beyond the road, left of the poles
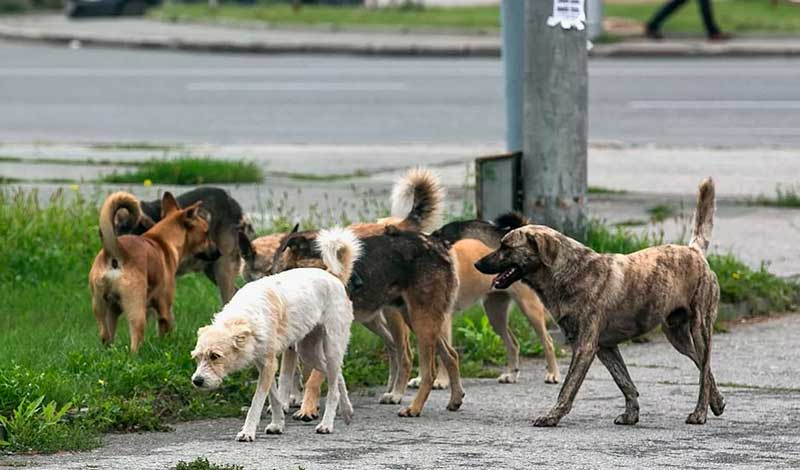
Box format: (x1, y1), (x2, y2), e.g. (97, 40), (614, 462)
(149, 0), (500, 30)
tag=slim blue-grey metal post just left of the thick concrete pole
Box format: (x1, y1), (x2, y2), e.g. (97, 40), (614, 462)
(500, 0), (525, 152)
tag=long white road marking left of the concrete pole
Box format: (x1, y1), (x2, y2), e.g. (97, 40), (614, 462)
(186, 81), (408, 91)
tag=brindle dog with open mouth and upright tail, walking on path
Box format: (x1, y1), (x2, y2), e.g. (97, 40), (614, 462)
(475, 178), (725, 426)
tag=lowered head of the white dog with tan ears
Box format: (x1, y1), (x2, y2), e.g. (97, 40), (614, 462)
(192, 320), (255, 390)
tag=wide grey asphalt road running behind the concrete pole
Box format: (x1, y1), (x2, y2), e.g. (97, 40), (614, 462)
(0, 43), (800, 146)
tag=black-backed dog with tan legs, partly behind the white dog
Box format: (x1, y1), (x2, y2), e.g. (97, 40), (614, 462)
(273, 225), (464, 417)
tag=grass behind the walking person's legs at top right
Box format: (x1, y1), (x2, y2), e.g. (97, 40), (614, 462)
(604, 0), (800, 35)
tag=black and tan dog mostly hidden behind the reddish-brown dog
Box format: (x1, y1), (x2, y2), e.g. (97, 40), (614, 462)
(114, 186), (253, 304)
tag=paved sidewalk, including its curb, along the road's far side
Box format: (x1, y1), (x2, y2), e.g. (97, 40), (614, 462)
(0, 14), (800, 57)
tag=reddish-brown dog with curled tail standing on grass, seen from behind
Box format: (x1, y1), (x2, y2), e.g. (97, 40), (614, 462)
(89, 192), (215, 352)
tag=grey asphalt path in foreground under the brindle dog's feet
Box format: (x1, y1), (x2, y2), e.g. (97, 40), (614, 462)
(7, 315), (800, 470)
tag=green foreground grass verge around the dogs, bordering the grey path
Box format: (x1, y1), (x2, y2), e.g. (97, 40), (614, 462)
(0, 191), (798, 452)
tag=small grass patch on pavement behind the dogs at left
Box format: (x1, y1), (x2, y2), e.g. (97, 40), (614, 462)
(102, 157), (264, 185)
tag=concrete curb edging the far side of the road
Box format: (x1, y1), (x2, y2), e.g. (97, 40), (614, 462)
(0, 24), (800, 57)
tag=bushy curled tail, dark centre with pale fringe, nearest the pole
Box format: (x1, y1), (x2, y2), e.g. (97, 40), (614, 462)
(391, 168), (445, 232)
